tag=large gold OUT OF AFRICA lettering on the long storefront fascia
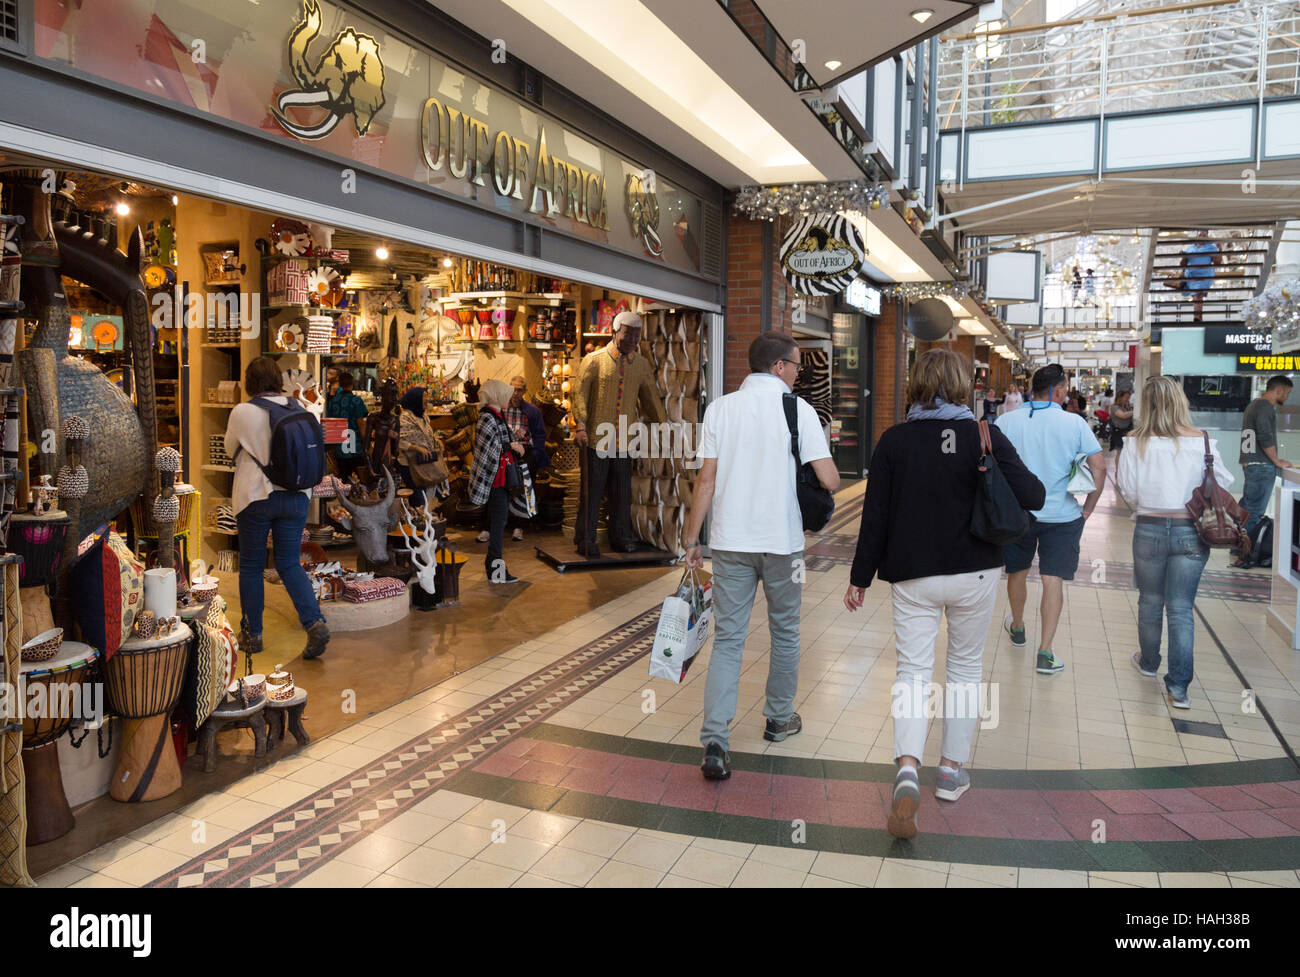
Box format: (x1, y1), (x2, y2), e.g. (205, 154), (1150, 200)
(420, 99), (610, 230)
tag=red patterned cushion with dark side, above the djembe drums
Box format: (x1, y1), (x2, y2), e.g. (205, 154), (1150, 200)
(73, 533), (144, 661)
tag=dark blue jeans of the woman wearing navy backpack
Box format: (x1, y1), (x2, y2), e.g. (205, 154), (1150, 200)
(235, 491), (325, 635)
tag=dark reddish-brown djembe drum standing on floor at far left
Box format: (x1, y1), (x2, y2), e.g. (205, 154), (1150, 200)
(18, 642), (99, 844)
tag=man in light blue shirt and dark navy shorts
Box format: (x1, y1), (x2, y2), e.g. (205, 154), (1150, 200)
(997, 362), (1106, 676)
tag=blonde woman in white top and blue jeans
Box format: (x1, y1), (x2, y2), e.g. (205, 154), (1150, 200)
(1118, 377), (1232, 709)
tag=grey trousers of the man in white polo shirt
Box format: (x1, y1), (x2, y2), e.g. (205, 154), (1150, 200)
(699, 550), (803, 750)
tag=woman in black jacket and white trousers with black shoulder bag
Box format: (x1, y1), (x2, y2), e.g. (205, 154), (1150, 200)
(844, 349), (1045, 838)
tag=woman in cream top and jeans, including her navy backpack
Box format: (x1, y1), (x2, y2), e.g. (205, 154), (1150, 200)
(226, 356), (329, 659)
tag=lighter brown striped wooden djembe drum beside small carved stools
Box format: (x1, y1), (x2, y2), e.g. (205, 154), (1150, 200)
(104, 624), (191, 802)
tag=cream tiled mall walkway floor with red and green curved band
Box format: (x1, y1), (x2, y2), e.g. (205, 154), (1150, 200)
(40, 470), (1300, 887)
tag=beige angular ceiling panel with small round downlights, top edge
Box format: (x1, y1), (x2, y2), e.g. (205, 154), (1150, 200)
(759, 0), (979, 88)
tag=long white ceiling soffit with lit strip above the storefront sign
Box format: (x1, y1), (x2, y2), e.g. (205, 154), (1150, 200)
(430, 0), (862, 187)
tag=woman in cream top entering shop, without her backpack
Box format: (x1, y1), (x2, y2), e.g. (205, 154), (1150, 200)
(226, 356), (329, 659)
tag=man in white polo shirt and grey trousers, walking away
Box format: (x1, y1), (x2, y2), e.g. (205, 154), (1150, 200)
(685, 333), (840, 781)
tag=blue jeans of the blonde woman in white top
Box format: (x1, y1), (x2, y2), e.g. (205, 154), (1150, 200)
(1134, 516), (1210, 695)
